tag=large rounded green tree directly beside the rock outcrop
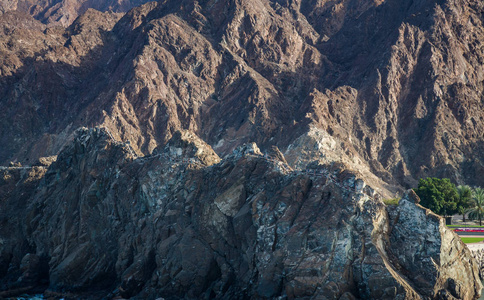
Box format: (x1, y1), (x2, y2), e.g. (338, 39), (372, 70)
(415, 177), (459, 216)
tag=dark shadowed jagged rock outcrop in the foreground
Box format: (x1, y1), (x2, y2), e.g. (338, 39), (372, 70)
(0, 128), (481, 299)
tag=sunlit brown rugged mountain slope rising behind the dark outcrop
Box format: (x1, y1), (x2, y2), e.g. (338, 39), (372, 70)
(0, 0), (484, 192)
